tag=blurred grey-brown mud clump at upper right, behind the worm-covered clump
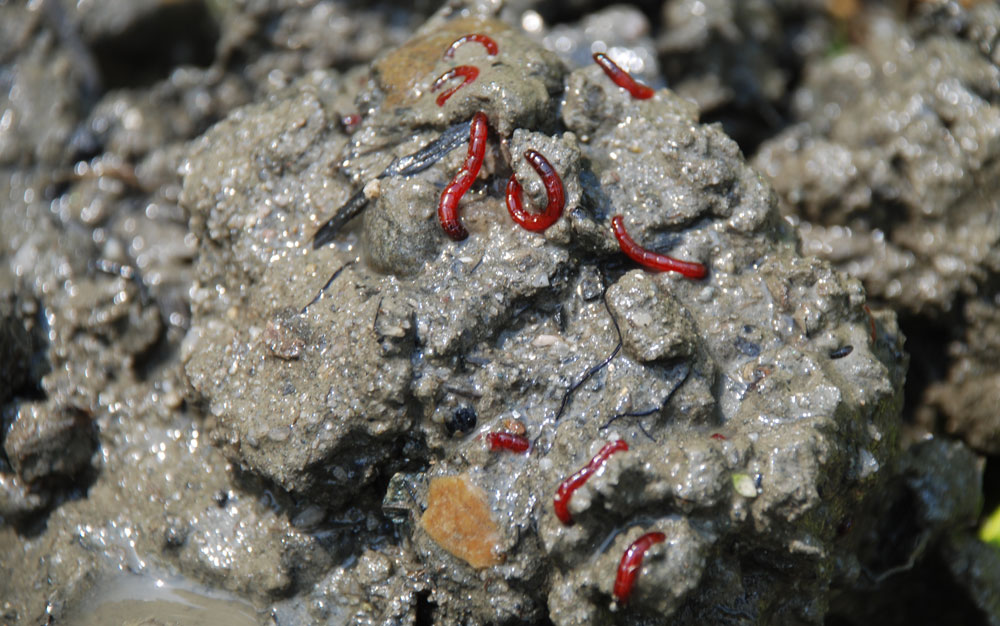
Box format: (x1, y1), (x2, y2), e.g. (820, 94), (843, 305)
(757, 3), (1000, 315)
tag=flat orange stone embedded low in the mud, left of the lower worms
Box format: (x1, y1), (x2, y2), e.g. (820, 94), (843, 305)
(420, 476), (503, 569)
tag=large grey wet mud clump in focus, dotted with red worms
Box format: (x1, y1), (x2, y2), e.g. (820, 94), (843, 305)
(181, 3), (905, 624)
